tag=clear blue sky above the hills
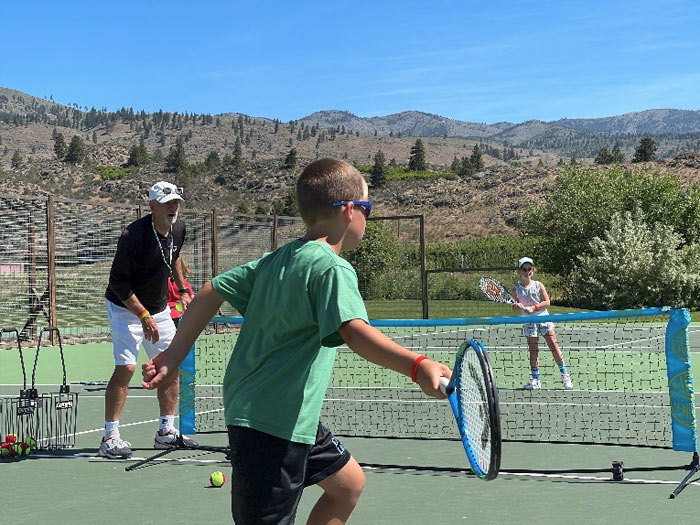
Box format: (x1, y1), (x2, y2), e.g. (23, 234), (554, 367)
(0, 0), (700, 123)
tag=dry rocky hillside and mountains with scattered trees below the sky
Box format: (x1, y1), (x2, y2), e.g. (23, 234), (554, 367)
(0, 88), (700, 241)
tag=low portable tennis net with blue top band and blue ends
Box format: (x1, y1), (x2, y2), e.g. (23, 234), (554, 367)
(180, 308), (697, 451)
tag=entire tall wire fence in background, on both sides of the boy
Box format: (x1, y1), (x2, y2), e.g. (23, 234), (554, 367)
(0, 196), (498, 341)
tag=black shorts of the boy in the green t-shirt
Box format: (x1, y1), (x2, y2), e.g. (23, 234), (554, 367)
(228, 423), (350, 525)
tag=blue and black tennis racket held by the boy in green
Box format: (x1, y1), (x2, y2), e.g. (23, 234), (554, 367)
(440, 339), (501, 481)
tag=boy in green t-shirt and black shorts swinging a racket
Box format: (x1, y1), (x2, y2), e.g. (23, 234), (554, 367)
(143, 158), (451, 525)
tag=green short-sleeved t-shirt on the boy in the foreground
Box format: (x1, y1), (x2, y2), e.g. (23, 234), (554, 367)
(212, 240), (367, 444)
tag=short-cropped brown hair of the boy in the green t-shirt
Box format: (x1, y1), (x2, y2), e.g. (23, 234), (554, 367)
(297, 158), (365, 225)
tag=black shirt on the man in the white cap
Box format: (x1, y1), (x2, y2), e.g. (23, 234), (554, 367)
(105, 214), (185, 314)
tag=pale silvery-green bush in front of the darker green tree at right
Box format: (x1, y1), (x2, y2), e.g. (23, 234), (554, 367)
(565, 209), (700, 309)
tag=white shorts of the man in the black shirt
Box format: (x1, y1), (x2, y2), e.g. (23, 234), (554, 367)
(105, 300), (175, 365)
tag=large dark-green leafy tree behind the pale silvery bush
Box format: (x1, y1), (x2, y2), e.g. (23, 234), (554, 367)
(521, 165), (700, 274)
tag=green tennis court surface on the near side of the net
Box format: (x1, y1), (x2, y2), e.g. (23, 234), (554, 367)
(0, 334), (700, 524)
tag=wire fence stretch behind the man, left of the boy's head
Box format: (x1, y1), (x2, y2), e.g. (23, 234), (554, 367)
(0, 196), (312, 341)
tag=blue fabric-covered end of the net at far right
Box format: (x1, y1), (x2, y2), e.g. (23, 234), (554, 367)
(665, 308), (698, 452)
